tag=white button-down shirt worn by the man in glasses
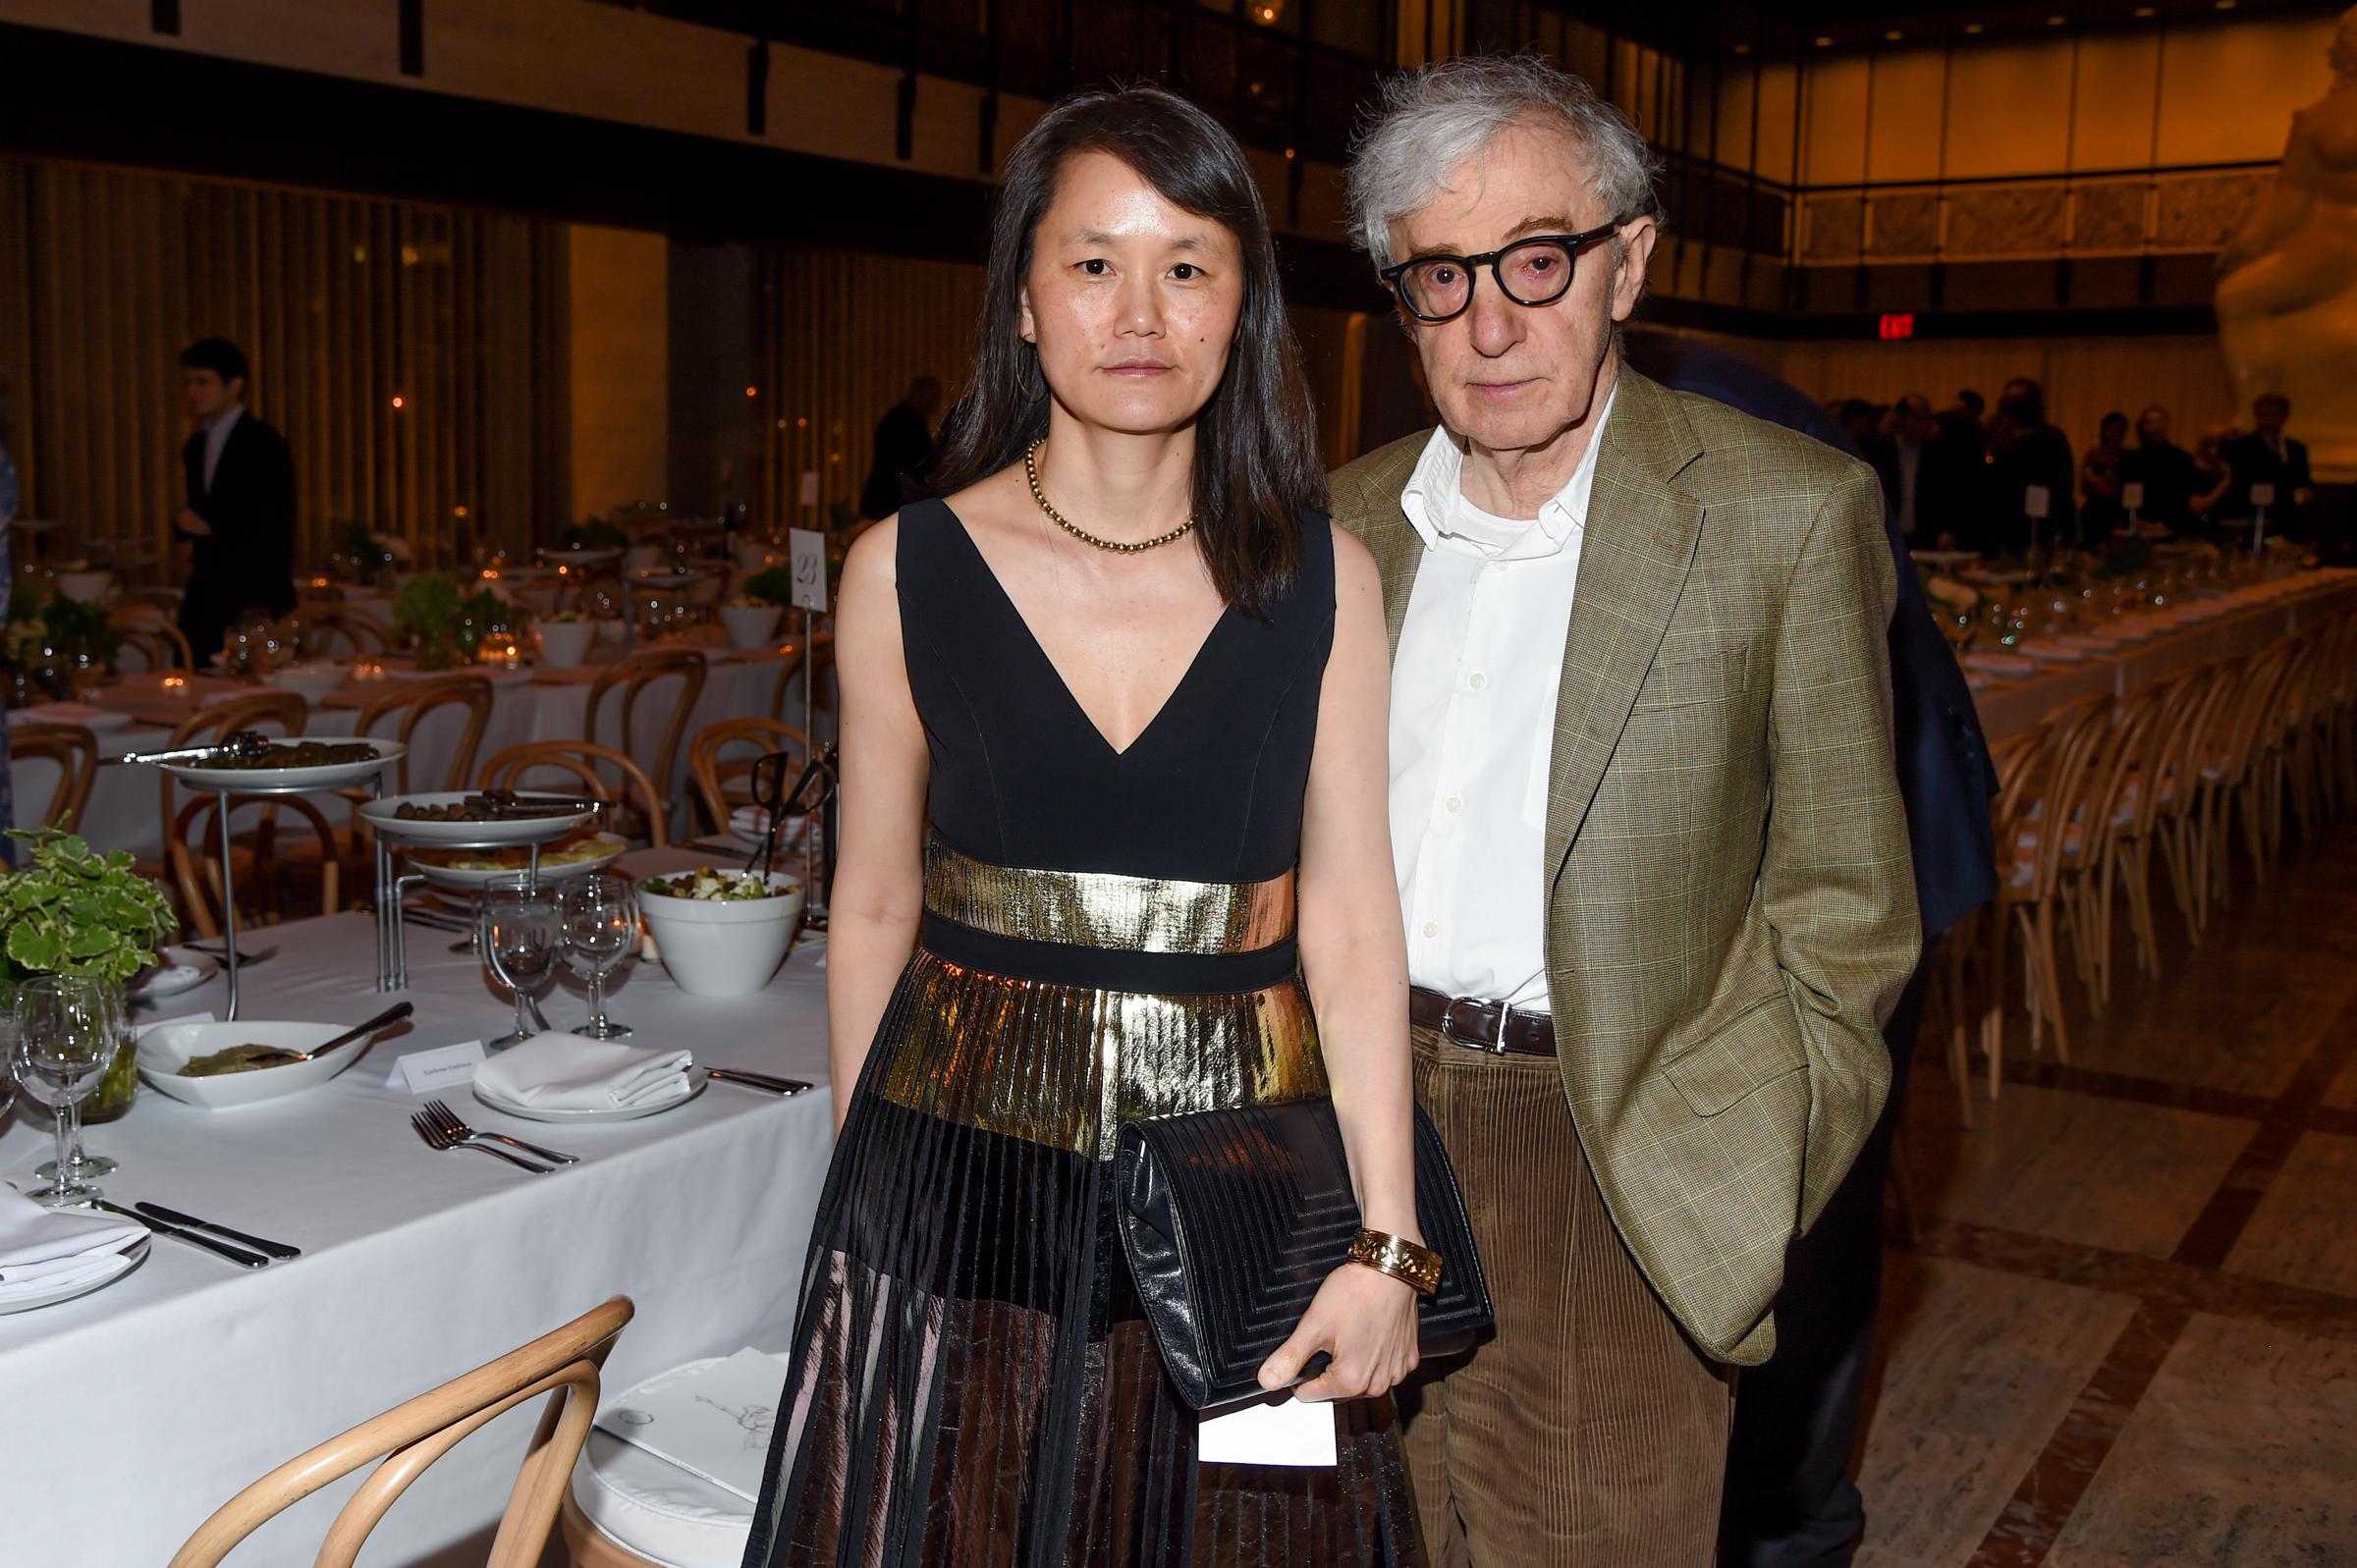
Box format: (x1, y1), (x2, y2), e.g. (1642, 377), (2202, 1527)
(1391, 394), (1613, 1009)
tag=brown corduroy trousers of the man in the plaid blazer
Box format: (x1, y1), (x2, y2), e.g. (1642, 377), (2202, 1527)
(1398, 1028), (1734, 1568)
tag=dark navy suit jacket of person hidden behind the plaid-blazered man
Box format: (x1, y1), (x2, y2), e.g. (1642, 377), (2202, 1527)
(1628, 330), (1997, 944)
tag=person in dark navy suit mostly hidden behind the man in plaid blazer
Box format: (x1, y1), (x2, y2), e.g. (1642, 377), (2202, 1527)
(1626, 330), (1997, 1568)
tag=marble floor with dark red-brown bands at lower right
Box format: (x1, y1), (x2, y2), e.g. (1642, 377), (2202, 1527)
(1857, 826), (2357, 1568)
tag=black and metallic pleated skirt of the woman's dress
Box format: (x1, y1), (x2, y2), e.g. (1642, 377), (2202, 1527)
(744, 947), (1421, 1568)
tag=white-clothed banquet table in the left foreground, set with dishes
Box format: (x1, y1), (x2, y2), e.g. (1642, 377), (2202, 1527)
(0, 849), (830, 1568)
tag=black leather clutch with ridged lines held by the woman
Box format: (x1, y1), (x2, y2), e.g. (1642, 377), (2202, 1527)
(1113, 1099), (1492, 1410)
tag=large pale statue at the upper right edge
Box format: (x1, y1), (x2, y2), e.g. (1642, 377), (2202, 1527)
(2218, 10), (2357, 481)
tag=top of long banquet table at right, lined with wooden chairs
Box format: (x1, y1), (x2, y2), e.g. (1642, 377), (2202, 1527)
(1973, 568), (2357, 742)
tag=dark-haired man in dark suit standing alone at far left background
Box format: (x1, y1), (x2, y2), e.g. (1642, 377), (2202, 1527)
(172, 337), (295, 660)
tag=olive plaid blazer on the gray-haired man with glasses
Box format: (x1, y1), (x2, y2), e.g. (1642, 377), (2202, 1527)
(1334, 365), (1919, 1363)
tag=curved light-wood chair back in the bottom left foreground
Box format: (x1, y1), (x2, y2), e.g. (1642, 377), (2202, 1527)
(170, 1297), (634, 1568)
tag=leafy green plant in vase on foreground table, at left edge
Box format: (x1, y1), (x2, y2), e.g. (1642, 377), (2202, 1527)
(0, 828), (179, 1122)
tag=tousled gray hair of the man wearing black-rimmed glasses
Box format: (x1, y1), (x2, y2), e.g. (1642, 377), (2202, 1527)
(1350, 54), (1662, 266)
